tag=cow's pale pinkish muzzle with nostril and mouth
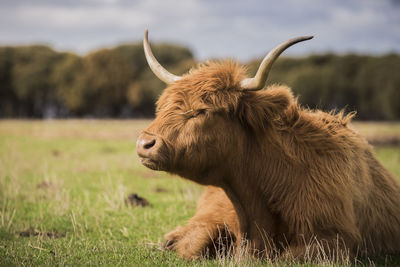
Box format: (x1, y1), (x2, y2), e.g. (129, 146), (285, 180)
(136, 132), (163, 170)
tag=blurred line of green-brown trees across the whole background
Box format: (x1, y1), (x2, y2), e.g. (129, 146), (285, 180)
(0, 43), (400, 120)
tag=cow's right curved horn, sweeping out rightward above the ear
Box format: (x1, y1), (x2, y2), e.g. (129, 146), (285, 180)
(240, 36), (314, 91)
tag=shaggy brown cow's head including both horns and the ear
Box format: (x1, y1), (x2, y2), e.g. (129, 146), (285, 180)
(136, 31), (312, 184)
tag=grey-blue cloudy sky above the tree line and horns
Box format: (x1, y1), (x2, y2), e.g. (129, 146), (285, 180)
(0, 0), (400, 60)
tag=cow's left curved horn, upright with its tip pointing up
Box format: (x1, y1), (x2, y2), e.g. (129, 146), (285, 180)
(143, 29), (182, 84)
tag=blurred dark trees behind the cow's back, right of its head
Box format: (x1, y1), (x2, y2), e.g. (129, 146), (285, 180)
(249, 54), (400, 120)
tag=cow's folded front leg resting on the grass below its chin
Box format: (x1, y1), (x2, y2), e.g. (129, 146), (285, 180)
(164, 186), (240, 259)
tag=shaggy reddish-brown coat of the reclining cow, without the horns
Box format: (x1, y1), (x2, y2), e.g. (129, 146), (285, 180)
(138, 61), (400, 259)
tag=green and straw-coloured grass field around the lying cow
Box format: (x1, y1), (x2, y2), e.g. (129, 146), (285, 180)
(0, 120), (400, 266)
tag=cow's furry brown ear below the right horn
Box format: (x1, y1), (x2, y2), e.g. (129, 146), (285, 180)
(238, 86), (294, 132)
